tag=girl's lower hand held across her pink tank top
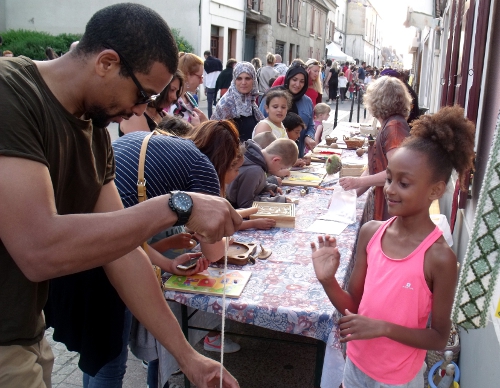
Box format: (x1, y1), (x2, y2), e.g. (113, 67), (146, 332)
(339, 309), (387, 342)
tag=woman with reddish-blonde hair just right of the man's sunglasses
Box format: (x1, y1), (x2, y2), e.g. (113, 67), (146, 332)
(169, 52), (207, 126)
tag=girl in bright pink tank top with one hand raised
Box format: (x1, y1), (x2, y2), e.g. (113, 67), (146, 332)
(311, 106), (474, 388)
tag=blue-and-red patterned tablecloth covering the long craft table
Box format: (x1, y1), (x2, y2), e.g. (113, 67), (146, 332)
(165, 151), (365, 388)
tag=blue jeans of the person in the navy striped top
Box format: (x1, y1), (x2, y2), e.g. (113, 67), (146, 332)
(83, 308), (132, 388)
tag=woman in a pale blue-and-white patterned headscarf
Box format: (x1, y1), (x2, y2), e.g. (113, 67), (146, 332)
(211, 62), (264, 141)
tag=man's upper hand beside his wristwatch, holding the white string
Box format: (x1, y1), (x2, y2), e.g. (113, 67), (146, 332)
(186, 193), (242, 243)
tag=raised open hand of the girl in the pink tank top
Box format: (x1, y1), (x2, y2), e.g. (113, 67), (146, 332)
(311, 235), (340, 283)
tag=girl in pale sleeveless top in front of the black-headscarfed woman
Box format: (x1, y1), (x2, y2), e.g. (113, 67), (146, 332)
(252, 90), (292, 139)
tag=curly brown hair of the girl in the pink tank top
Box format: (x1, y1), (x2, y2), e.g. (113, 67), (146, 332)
(401, 105), (476, 189)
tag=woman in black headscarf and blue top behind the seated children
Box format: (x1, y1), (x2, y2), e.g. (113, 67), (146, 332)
(259, 63), (316, 158)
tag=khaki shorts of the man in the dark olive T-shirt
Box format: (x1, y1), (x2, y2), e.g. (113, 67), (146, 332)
(0, 337), (54, 388)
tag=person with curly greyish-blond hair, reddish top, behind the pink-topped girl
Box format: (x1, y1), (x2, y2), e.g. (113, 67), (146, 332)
(339, 77), (411, 220)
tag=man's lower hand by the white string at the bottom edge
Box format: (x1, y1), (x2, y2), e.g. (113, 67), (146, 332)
(180, 353), (240, 388)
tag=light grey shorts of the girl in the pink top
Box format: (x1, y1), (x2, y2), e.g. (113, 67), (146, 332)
(342, 357), (427, 388)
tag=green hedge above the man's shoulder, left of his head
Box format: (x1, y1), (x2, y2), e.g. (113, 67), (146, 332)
(0, 30), (81, 60)
